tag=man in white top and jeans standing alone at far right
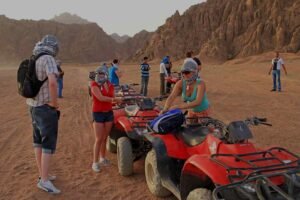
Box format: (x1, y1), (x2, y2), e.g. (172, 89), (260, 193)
(269, 52), (287, 92)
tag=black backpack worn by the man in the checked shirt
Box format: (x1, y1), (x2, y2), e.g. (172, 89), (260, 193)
(17, 54), (48, 98)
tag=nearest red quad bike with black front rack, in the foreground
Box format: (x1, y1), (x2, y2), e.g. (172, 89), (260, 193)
(145, 117), (300, 200)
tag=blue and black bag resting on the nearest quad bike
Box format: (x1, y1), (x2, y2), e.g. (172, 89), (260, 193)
(150, 109), (185, 134)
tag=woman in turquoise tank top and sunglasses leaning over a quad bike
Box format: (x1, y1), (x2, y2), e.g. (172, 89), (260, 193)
(162, 60), (210, 117)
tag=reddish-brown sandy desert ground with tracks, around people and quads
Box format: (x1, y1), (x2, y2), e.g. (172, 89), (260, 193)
(0, 53), (300, 200)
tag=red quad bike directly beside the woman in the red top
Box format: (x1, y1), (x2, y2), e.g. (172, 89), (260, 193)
(106, 97), (163, 176)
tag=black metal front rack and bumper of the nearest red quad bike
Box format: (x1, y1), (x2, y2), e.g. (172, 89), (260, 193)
(211, 147), (300, 200)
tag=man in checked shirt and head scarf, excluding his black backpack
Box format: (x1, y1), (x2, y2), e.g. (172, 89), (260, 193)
(25, 35), (60, 194)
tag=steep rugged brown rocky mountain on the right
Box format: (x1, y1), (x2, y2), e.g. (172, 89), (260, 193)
(133, 0), (300, 61)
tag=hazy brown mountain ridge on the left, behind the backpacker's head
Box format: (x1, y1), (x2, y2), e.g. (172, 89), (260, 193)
(0, 15), (122, 63)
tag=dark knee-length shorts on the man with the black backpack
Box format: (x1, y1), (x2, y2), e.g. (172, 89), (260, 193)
(30, 105), (58, 154)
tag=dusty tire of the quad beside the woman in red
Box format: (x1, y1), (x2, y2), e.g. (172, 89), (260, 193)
(117, 137), (133, 176)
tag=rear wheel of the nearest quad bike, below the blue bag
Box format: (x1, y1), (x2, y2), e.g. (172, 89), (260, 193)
(145, 149), (171, 197)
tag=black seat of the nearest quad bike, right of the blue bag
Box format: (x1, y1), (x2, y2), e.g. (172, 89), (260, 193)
(179, 126), (209, 146)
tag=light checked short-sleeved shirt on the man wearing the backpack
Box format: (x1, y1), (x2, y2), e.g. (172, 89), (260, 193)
(26, 55), (59, 107)
